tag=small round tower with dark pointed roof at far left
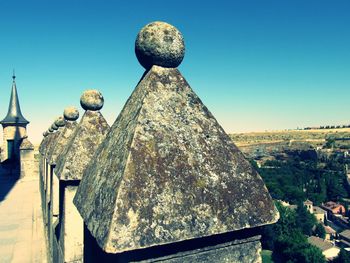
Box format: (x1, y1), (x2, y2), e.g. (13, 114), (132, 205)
(0, 74), (29, 161)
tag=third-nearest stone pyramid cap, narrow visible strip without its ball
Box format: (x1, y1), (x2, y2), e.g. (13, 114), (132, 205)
(48, 121), (78, 164)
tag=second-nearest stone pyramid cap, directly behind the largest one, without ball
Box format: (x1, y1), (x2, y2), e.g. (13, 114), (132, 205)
(55, 110), (109, 180)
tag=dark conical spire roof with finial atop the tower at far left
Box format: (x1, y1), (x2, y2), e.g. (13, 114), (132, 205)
(0, 70), (29, 125)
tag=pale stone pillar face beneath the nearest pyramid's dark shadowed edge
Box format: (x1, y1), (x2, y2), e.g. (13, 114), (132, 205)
(138, 237), (262, 263)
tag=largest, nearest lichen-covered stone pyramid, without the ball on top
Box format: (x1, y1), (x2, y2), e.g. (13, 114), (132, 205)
(74, 66), (279, 253)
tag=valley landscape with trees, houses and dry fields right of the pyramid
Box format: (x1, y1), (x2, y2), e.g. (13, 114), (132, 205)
(230, 127), (350, 262)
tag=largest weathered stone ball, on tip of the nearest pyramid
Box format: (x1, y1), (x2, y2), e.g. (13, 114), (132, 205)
(135, 21), (185, 70)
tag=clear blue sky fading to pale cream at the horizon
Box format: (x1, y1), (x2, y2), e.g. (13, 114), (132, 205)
(0, 0), (350, 143)
